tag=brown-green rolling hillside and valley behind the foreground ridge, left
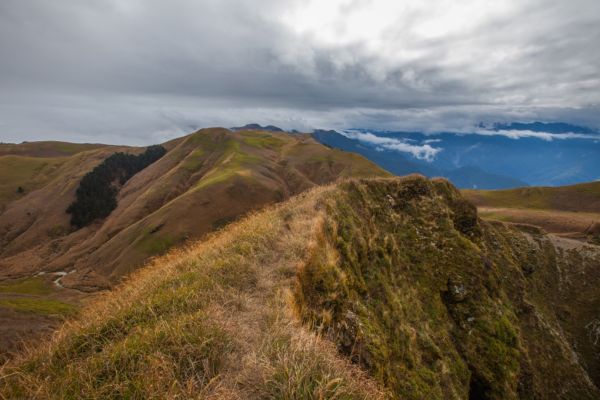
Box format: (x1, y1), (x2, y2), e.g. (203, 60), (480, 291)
(0, 128), (389, 356)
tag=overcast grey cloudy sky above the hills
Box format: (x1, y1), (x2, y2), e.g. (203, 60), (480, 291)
(0, 0), (600, 144)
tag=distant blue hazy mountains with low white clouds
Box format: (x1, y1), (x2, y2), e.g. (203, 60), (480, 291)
(313, 122), (600, 189)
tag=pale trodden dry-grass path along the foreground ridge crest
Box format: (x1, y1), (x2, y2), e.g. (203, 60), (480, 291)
(192, 196), (384, 400)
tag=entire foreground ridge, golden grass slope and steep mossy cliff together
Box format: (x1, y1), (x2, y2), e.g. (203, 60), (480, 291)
(0, 177), (600, 399)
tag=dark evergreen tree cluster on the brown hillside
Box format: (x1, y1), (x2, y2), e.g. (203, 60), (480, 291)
(66, 145), (167, 229)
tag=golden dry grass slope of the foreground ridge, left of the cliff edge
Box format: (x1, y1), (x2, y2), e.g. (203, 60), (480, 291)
(0, 184), (384, 399)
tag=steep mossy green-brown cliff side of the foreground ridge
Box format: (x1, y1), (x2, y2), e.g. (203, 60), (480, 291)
(296, 176), (600, 399)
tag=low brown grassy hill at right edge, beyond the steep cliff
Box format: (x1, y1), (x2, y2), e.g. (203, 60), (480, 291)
(463, 182), (600, 243)
